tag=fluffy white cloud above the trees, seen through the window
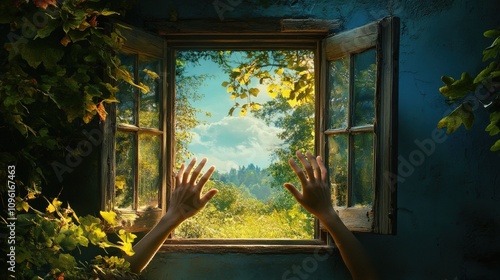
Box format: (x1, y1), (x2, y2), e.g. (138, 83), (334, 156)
(189, 116), (282, 172)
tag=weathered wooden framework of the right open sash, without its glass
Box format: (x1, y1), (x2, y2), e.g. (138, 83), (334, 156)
(320, 17), (399, 234)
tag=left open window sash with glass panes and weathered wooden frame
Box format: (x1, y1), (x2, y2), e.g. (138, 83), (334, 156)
(101, 27), (168, 232)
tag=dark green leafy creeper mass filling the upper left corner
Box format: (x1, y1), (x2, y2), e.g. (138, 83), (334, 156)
(0, 0), (144, 195)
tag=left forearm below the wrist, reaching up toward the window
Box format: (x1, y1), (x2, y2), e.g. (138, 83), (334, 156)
(126, 214), (180, 273)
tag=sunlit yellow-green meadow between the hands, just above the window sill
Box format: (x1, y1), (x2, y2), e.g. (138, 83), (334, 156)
(175, 181), (314, 239)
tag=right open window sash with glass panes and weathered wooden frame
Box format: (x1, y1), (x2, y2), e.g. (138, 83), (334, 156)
(321, 18), (399, 234)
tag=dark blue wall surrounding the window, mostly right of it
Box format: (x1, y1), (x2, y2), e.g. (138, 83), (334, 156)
(135, 0), (500, 279)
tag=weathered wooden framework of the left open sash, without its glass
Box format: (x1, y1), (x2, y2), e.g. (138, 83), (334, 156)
(100, 25), (169, 232)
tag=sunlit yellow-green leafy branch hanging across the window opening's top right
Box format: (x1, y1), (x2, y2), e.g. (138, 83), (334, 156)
(222, 50), (314, 116)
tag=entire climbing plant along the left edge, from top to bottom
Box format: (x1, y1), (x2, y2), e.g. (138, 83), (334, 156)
(0, 0), (142, 279)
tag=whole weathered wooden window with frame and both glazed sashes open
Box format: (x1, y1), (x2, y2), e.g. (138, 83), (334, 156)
(103, 18), (399, 247)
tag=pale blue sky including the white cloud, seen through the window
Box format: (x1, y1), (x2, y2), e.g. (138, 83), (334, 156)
(180, 52), (282, 173)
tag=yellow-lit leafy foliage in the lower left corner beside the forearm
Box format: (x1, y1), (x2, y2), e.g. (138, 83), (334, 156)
(9, 194), (138, 279)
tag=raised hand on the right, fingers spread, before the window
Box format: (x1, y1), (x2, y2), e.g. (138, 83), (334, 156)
(284, 151), (337, 223)
